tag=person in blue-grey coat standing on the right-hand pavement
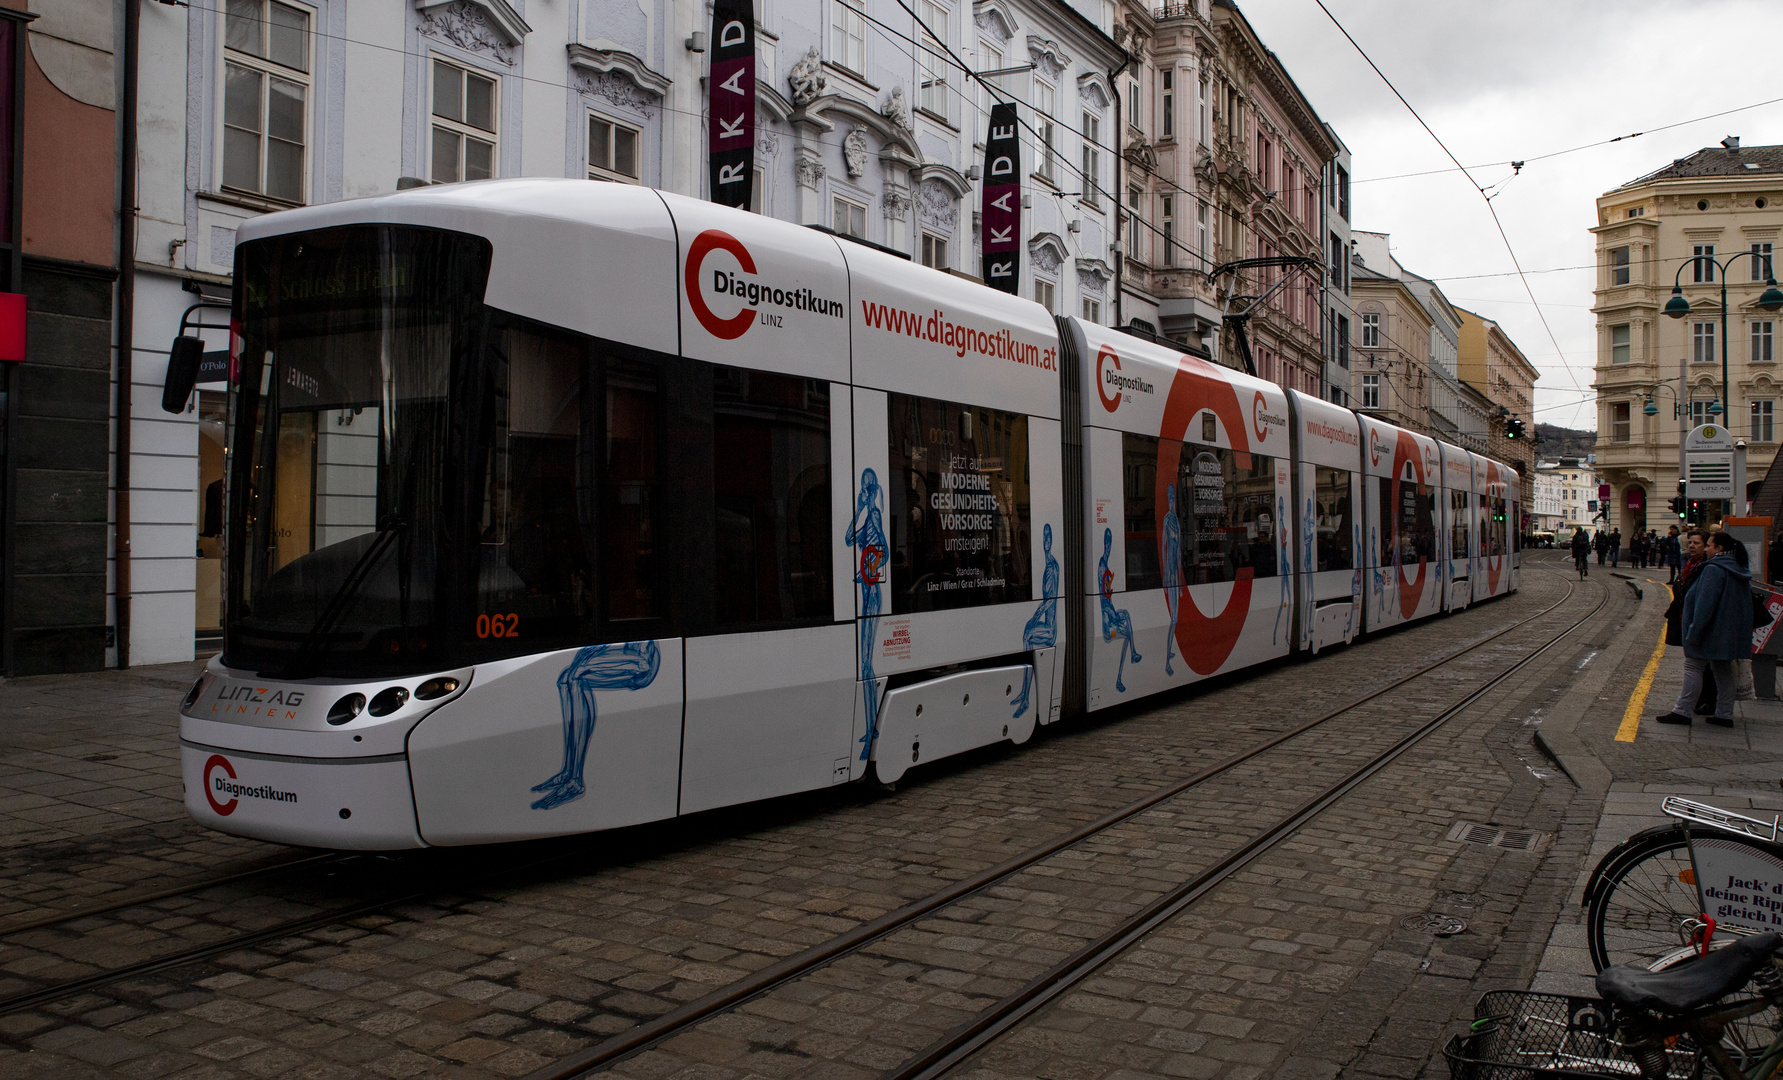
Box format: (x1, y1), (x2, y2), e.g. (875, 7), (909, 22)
(1658, 533), (1753, 727)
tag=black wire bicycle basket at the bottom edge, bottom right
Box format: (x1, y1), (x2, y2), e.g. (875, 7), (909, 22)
(1442, 991), (1697, 1080)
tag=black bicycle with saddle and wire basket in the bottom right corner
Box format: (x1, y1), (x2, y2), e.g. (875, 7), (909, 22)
(1442, 932), (1783, 1080)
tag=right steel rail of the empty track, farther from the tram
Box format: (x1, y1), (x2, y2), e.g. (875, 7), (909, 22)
(898, 570), (1610, 1080)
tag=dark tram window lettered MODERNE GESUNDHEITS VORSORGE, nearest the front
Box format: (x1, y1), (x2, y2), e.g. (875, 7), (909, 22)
(888, 394), (1032, 611)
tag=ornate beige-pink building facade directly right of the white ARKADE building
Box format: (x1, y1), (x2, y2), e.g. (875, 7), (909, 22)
(1120, 0), (1348, 397)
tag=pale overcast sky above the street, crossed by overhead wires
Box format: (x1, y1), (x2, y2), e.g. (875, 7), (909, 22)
(1239, 0), (1783, 436)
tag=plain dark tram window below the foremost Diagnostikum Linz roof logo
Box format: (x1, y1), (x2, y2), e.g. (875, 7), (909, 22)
(711, 367), (833, 631)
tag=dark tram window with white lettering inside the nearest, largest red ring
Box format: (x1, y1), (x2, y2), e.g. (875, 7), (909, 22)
(1177, 442), (1286, 585)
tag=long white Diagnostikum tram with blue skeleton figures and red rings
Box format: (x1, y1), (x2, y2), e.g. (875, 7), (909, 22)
(180, 180), (1521, 850)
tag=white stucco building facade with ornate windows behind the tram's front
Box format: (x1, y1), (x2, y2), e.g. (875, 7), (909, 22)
(130, 0), (1127, 663)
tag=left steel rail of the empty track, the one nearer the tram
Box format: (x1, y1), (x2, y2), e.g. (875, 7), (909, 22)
(522, 566), (1608, 1080)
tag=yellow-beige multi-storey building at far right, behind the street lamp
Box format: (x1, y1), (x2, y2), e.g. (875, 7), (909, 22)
(1590, 137), (1783, 533)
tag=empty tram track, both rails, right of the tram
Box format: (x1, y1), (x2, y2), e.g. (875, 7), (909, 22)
(524, 566), (1610, 1080)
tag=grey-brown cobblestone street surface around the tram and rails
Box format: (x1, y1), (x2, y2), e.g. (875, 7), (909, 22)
(0, 556), (1783, 1080)
